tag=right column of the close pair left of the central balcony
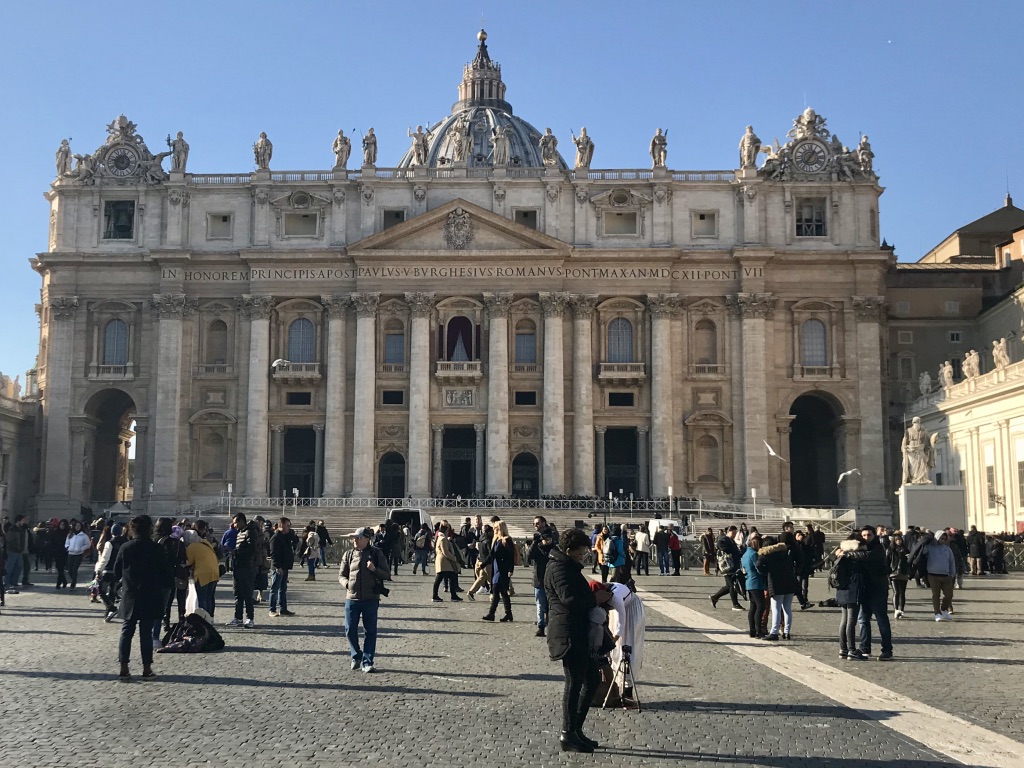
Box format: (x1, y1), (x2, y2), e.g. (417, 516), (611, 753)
(352, 293), (381, 497)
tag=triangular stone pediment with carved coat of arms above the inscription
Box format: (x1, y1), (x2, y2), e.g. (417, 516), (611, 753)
(348, 199), (569, 256)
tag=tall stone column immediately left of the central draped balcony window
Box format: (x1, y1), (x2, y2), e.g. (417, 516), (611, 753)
(406, 293), (434, 498)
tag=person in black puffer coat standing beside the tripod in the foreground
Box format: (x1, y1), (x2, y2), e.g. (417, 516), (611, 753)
(544, 528), (600, 752)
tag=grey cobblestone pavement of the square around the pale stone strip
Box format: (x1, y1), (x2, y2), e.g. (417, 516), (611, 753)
(0, 566), (1024, 768)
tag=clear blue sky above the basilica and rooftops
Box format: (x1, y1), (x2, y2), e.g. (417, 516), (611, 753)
(0, 0), (1024, 376)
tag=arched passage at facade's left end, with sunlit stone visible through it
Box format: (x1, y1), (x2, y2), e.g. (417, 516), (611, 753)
(81, 389), (141, 511)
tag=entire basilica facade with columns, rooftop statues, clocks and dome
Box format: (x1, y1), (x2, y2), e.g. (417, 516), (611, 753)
(33, 31), (893, 519)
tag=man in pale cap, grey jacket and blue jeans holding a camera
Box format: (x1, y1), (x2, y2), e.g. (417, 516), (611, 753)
(338, 527), (391, 674)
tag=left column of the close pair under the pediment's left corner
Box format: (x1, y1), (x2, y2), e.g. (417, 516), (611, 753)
(321, 295), (351, 499)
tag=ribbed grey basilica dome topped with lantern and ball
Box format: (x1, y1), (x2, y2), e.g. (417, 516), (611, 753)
(398, 30), (567, 168)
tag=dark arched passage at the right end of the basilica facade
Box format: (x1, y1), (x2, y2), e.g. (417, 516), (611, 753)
(790, 394), (840, 507)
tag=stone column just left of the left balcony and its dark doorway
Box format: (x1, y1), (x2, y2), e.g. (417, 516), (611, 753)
(238, 296), (273, 497)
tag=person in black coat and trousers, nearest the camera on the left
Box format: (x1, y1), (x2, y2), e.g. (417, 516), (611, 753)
(114, 515), (174, 678)
